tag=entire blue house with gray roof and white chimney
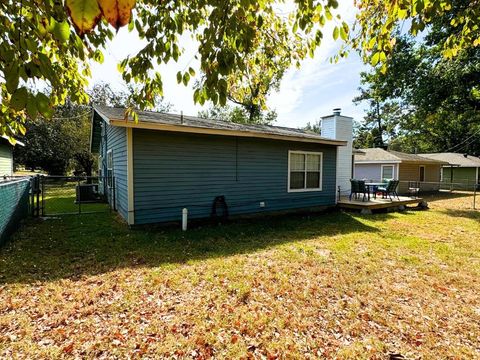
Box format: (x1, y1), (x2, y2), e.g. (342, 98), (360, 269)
(91, 107), (352, 225)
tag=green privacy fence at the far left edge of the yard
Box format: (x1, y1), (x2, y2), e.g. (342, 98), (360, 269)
(0, 178), (30, 245)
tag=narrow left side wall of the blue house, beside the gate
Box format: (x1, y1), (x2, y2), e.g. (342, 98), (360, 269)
(100, 123), (128, 219)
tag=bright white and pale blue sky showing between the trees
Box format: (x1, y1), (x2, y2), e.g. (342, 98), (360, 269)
(91, 1), (365, 127)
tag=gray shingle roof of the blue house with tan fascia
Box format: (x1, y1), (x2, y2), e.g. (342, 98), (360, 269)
(94, 106), (346, 146)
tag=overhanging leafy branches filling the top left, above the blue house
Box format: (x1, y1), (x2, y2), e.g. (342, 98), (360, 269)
(0, 0), (348, 139)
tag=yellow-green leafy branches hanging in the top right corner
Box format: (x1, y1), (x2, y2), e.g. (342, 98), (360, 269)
(349, 0), (480, 68)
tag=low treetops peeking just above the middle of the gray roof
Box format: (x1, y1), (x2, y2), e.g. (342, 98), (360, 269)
(198, 105), (277, 125)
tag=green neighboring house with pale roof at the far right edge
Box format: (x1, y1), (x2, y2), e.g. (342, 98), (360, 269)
(420, 153), (480, 185)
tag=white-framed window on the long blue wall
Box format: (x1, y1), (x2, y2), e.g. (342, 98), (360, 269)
(288, 151), (323, 192)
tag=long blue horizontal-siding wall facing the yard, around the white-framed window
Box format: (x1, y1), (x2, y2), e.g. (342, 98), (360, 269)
(133, 129), (336, 224)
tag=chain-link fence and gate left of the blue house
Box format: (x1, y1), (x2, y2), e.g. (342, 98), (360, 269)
(39, 176), (115, 216)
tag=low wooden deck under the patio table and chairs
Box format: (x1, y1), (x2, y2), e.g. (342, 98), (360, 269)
(337, 196), (426, 214)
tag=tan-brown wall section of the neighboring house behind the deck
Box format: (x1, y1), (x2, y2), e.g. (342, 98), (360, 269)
(398, 163), (441, 193)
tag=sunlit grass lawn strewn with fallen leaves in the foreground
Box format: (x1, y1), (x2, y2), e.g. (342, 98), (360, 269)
(0, 195), (480, 359)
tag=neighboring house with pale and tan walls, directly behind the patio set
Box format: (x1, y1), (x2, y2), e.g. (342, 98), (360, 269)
(354, 148), (447, 193)
